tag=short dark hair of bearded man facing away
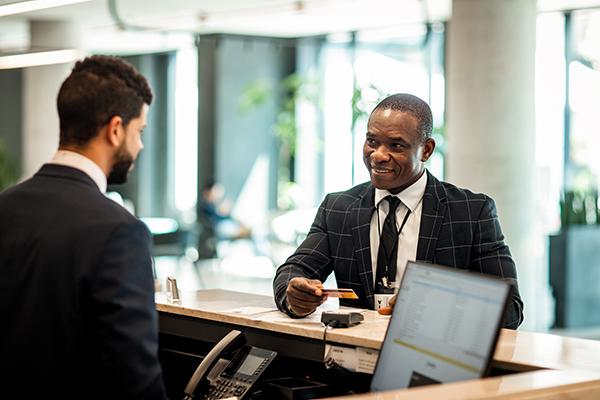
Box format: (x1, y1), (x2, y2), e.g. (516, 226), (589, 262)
(56, 55), (152, 145)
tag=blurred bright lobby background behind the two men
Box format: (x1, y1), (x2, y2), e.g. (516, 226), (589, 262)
(0, 0), (600, 339)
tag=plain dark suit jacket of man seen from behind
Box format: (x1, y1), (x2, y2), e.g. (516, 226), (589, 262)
(0, 164), (166, 399)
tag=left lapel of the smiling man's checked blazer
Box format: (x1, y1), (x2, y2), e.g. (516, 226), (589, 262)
(352, 185), (375, 309)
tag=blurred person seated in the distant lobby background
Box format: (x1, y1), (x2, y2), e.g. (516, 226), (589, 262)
(201, 181), (252, 240)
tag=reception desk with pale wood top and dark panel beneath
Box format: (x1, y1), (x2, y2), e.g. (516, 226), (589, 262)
(156, 290), (600, 400)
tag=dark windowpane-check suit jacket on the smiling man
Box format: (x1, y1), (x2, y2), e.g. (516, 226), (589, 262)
(273, 172), (523, 329)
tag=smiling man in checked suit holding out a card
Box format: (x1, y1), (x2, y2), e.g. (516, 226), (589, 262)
(273, 94), (523, 329)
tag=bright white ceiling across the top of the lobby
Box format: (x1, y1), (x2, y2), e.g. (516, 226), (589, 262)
(0, 0), (600, 52)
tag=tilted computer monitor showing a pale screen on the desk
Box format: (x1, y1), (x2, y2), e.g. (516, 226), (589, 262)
(371, 261), (510, 391)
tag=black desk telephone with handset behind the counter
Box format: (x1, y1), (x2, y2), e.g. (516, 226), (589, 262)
(183, 330), (277, 400)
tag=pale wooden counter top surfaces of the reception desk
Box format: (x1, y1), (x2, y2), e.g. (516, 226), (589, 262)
(156, 289), (600, 400)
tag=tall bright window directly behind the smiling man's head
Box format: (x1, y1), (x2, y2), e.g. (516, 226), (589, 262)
(324, 24), (444, 192)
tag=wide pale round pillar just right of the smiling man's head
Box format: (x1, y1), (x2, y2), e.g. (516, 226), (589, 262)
(446, 0), (547, 328)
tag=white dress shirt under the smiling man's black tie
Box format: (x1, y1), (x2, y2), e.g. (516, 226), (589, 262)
(369, 172), (427, 285)
